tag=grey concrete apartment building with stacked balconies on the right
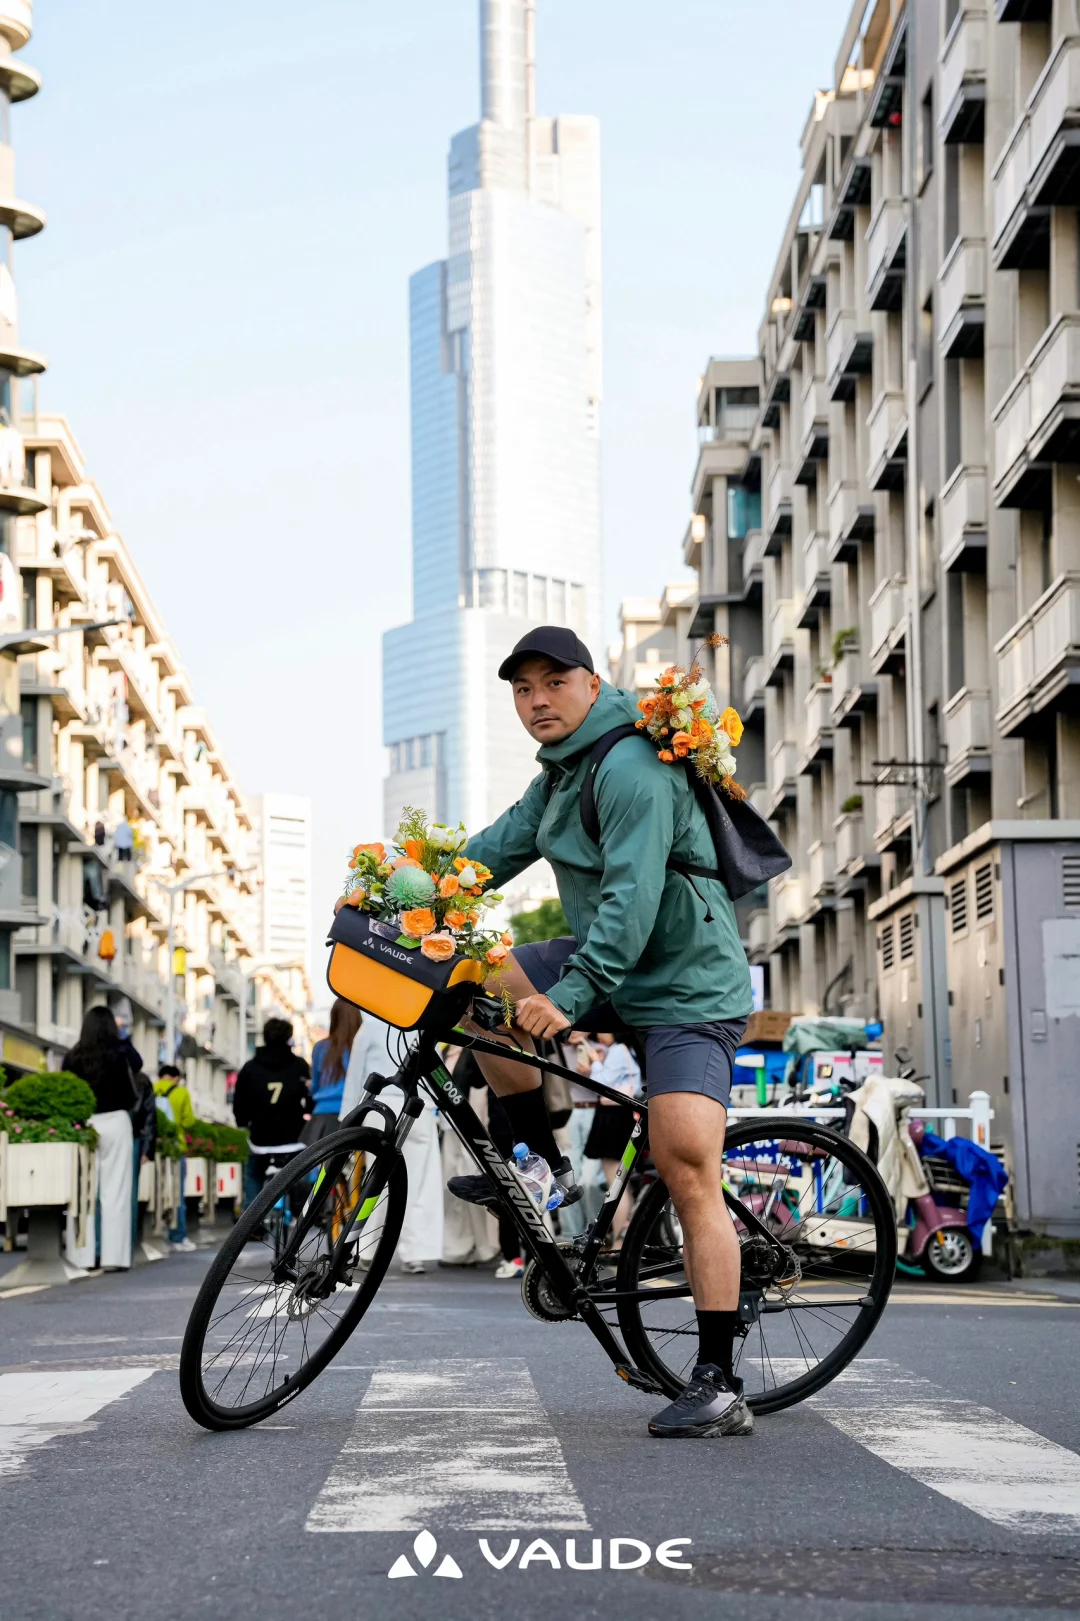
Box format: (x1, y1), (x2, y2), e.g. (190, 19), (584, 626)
(688, 0), (1080, 1219)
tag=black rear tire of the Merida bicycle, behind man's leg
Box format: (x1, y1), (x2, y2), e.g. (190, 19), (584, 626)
(616, 1118), (897, 1414)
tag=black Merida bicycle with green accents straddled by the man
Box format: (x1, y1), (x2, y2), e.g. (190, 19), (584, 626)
(180, 986), (897, 1430)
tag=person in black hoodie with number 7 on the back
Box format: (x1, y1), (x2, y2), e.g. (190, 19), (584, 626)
(232, 1018), (313, 1204)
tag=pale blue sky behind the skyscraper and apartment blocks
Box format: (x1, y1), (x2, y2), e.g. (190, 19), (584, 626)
(13, 0), (850, 973)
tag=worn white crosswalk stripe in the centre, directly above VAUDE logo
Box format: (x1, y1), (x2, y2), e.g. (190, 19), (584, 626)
(306, 1357), (589, 1532)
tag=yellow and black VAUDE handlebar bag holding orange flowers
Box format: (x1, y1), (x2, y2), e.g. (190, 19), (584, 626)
(326, 906), (483, 1033)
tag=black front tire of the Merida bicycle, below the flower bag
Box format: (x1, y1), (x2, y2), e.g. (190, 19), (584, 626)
(180, 1127), (409, 1430)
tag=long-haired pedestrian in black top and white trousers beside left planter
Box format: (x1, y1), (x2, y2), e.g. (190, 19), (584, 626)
(63, 1007), (143, 1271)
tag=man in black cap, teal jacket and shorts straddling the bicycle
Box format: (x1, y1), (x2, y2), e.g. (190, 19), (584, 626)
(449, 626), (754, 1436)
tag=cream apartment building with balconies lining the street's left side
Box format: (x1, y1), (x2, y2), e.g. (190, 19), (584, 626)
(0, 0), (310, 1114)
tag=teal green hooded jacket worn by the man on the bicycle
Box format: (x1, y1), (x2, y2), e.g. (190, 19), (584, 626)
(467, 682), (751, 1029)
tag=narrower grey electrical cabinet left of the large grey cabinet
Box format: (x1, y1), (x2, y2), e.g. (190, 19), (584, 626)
(866, 877), (954, 1109)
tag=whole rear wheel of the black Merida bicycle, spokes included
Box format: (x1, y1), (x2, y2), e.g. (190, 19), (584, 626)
(616, 1120), (897, 1414)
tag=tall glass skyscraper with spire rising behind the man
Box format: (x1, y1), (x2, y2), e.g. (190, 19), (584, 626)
(383, 0), (600, 832)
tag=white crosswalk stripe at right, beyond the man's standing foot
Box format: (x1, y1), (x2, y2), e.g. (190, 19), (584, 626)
(811, 1358), (1080, 1535)
